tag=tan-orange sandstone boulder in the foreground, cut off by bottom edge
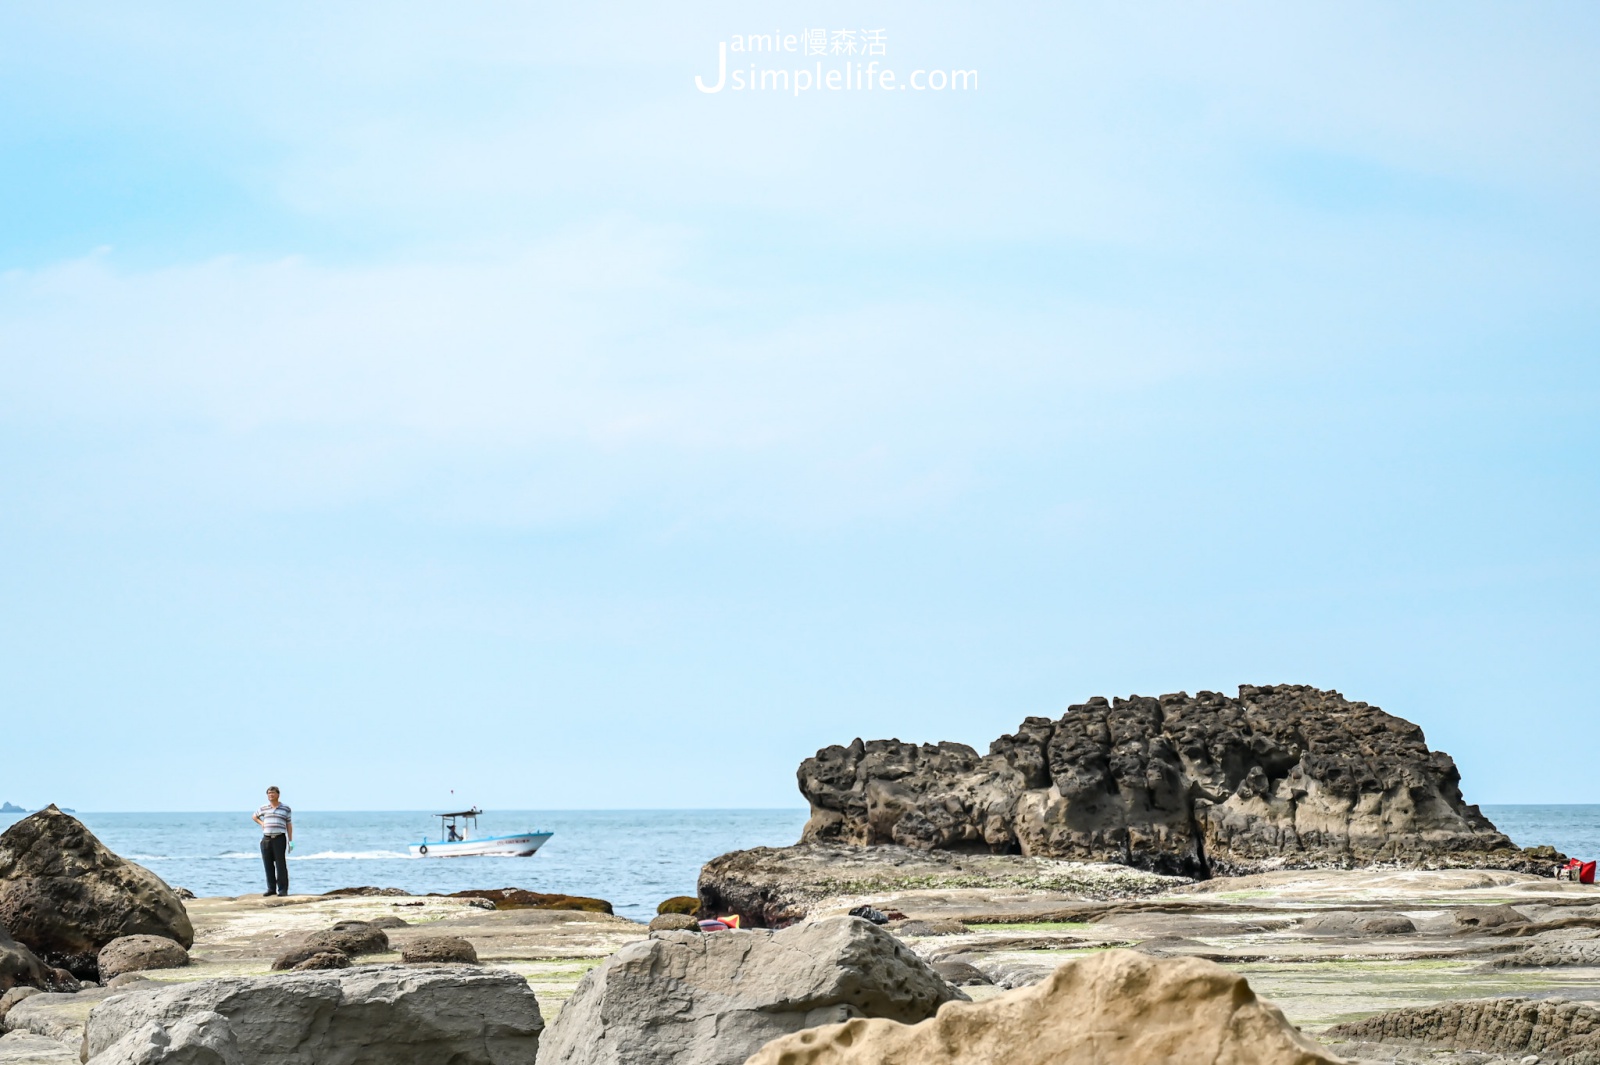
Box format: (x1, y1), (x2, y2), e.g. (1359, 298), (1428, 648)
(749, 950), (1339, 1065)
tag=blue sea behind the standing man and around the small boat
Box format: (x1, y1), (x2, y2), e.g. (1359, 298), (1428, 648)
(0, 806), (1600, 919)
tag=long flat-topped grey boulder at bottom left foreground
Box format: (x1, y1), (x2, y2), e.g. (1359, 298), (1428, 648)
(85, 966), (544, 1065)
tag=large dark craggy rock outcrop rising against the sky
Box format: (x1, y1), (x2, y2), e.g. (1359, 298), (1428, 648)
(798, 684), (1555, 878)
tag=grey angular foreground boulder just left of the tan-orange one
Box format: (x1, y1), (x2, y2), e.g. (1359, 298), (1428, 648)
(539, 918), (965, 1065)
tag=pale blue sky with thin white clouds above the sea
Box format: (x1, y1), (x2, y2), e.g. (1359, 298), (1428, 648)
(0, 0), (1600, 811)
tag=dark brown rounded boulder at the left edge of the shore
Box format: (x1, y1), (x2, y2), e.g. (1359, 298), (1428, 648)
(0, 806), (195, 979)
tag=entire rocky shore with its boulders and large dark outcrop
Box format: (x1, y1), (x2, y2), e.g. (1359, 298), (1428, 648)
(0, 674), (1600, 1065)
